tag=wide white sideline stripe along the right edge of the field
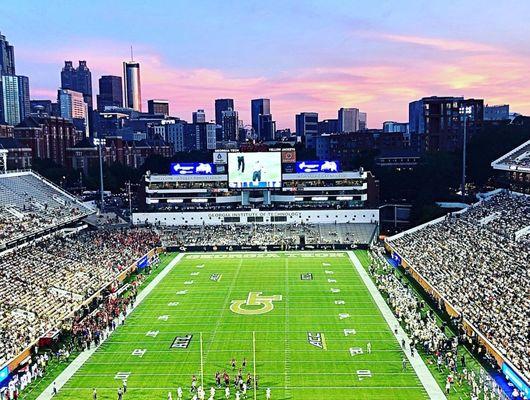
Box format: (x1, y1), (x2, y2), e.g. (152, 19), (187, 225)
(348, 251), (446, 400)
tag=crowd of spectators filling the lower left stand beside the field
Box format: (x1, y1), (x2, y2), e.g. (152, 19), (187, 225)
(0, 229), (159, 365)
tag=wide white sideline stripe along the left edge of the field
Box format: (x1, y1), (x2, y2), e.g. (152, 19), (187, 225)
(37, 253), (184, 400)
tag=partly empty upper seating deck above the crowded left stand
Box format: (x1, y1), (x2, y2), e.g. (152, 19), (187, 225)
(0, 171), (93, 247)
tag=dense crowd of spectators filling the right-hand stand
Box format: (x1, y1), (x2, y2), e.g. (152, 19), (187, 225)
(389, 192), (530, 379)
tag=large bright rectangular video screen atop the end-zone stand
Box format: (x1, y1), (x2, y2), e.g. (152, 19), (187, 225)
(228, 152), (282, 189)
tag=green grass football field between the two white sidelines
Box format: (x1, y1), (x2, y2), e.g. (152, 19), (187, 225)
(56, 252), (427, 400)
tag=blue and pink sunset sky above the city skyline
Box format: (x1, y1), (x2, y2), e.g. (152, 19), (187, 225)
(0, 0), (530, 129)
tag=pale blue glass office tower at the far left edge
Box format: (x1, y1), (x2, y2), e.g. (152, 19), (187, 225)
(0, 75), (30, 125)
